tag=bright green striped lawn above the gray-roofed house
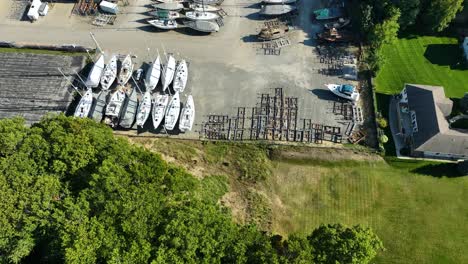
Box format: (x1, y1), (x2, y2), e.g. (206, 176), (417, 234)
(375, 36), (468, 98)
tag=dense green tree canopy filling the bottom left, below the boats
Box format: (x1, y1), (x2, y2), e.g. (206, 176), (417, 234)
(0, 116), (379, 263)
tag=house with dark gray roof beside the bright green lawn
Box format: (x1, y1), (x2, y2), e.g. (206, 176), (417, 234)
(396, 84), (468, 160)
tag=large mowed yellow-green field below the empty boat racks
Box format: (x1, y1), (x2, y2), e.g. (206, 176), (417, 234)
(266, 161), (468, 263)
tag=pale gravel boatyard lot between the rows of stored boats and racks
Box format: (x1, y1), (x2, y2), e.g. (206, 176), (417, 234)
(0, 0), (358, 141)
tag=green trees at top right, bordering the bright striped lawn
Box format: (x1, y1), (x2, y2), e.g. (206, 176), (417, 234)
(355, 0), (464, 73)
